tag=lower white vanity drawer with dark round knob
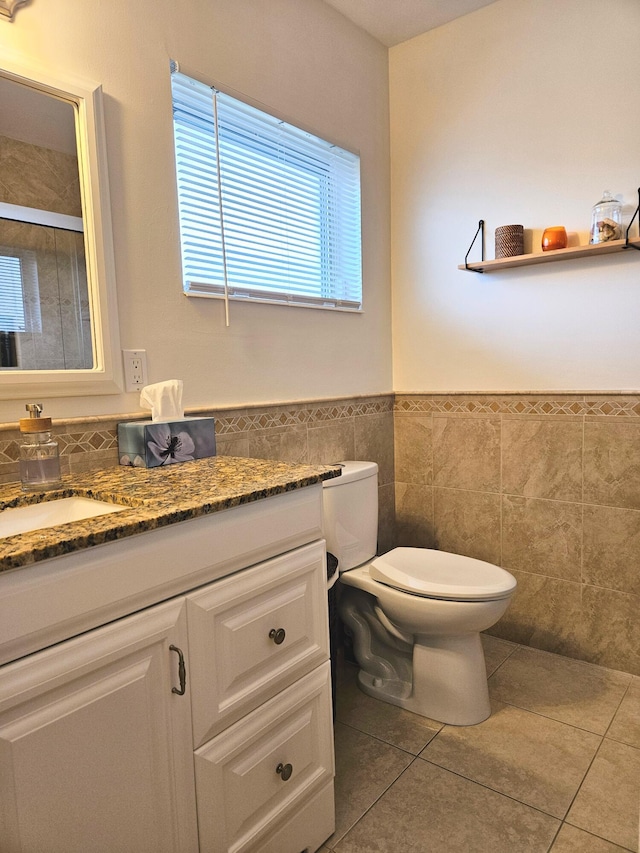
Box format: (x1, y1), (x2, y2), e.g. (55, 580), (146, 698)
(195, 662), (334, 853)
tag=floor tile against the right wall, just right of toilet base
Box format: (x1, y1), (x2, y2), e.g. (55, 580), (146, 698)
(489, 647), (632, 735)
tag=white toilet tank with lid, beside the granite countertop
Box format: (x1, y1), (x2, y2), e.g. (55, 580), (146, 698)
(322, 462), (378, 572)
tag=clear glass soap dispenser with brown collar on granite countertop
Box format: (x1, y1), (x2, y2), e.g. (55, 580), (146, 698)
(20, 403), (60, 492)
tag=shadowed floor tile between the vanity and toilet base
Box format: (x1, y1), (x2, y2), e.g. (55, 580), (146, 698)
(337, 665), (442, 755)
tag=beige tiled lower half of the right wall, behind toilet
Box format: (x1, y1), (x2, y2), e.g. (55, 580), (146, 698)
(395, 394), (640, 675)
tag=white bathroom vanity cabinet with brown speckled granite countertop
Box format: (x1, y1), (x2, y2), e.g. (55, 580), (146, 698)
(0, 457), (338, 853)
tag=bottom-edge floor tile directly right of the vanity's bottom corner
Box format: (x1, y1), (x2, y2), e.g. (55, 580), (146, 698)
(335, 760), (559, 853)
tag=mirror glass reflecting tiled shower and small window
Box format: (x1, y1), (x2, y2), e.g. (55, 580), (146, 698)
(0, 77), (93, 370)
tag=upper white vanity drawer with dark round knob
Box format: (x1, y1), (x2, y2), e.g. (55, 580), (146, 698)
(187, 541), (329, 747)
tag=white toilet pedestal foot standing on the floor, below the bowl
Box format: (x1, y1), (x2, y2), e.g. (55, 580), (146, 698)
(358, 633), (491, 726)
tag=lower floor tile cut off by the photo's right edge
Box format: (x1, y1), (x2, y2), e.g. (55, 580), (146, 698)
(567, 738), (640, 850)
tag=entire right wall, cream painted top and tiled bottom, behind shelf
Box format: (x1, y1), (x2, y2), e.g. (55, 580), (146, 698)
(390, 0), (640, 674)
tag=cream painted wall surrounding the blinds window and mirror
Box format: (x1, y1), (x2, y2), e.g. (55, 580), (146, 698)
(0, 0), (392, 422)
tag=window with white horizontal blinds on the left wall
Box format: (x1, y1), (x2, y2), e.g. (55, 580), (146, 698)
(171, 70), (362, 311)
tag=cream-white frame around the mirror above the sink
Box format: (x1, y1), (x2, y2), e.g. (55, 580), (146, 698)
(0, 53), (123, 400)
